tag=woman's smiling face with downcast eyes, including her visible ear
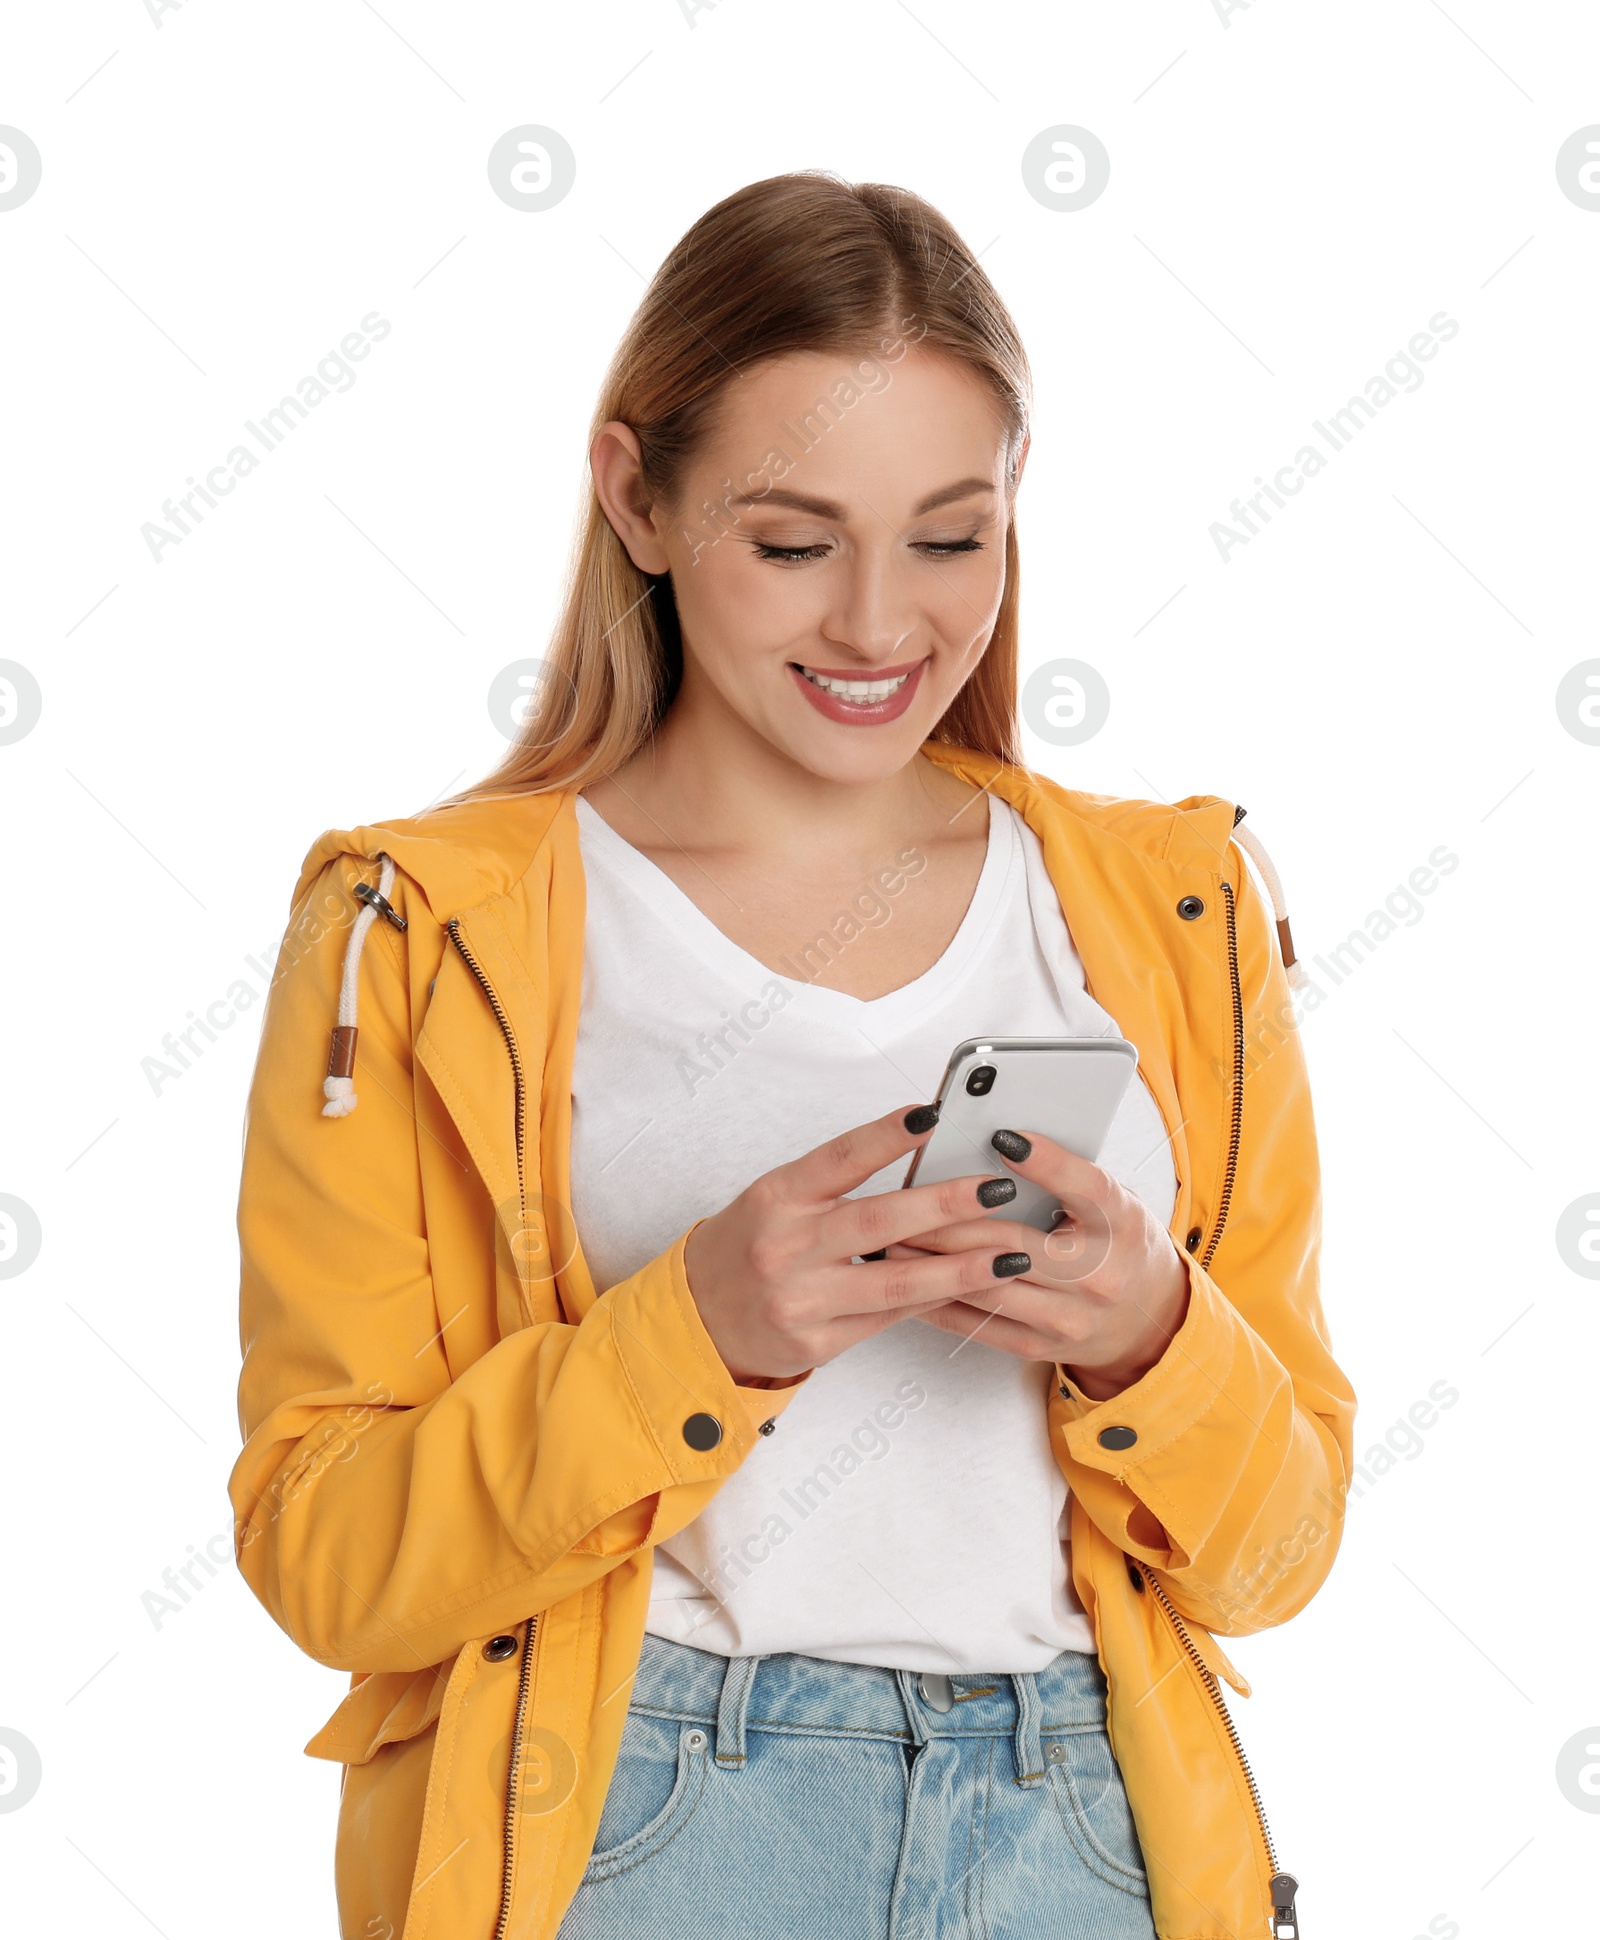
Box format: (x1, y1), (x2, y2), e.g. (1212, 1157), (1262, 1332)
(595, 343), (1010, 782)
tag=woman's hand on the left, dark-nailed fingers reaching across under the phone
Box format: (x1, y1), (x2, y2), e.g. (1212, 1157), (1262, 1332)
(685, 1106), (1043, 1387)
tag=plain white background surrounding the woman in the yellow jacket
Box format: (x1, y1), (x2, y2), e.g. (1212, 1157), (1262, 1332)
(0, 0), (1600, 1940)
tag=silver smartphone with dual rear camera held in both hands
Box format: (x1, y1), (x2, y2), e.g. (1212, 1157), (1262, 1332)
(906, 1038), (1138, 1232)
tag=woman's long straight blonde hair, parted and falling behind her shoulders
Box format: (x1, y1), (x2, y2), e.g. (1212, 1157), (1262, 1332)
(450, 173), (1032, 801)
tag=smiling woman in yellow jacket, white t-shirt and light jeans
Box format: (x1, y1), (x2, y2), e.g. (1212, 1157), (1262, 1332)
(233, 175), (1352, 1940)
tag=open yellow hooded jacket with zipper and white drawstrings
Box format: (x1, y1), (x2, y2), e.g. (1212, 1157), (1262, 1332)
(231, 743), (1354, 1940)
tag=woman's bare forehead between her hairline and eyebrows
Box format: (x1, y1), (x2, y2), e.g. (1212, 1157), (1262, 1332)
(700, 347), (1007, 497)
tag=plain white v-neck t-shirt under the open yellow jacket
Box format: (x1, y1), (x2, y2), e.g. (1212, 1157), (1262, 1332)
(572, 797), (1177, 1672)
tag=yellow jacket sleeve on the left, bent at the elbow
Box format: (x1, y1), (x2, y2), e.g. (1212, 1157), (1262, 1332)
(229, 857), (793, 1672)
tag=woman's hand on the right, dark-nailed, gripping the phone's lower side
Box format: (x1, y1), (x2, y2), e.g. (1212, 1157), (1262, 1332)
(890, 1131), (1189, 1401)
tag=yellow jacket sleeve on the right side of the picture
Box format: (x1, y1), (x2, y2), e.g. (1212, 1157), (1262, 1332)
(1057, 844), (1356, 1635)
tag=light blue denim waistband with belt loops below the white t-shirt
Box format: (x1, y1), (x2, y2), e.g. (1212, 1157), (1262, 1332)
(630, 1632), (1105, 1783)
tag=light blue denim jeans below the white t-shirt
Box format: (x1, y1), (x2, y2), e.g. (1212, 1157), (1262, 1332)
(559, 1635), (1156, 1940)
